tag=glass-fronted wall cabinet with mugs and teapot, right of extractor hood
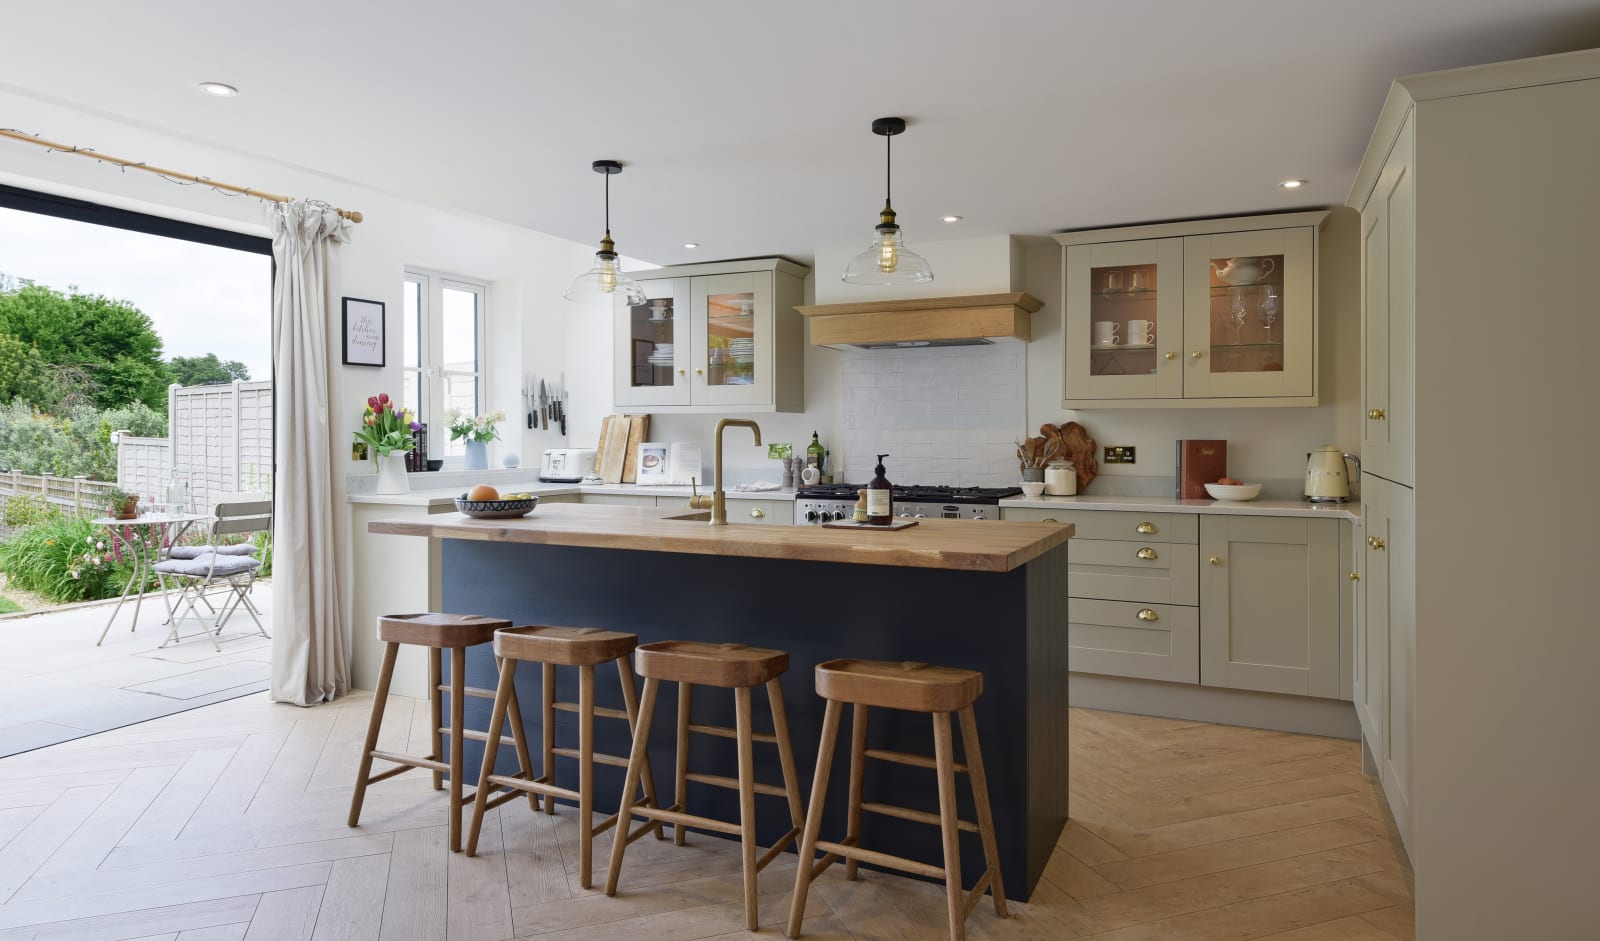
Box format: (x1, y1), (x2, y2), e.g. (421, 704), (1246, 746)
(1056, 213), (1326, 408)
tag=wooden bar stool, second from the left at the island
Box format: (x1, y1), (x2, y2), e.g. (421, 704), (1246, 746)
(467, 627), (666, 888)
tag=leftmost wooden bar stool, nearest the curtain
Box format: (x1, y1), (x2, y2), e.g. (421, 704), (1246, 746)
(347, 613), (538, 853)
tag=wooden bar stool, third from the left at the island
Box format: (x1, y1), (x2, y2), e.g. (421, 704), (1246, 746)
(605, 640), (803, 931)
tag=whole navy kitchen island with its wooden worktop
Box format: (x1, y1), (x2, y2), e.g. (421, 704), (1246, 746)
(371, 504), (1072, 899)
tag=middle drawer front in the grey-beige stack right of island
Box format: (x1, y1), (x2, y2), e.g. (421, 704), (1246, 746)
(1067, 538), (1200, 605)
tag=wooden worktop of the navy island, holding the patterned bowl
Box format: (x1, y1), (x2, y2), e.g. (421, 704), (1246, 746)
(368, 504), (1072, 571)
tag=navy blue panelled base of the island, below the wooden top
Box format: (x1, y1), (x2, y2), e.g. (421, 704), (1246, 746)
(442, 534), (1067, 899)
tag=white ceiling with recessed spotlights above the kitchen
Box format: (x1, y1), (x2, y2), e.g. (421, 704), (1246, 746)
(0, 0), (1600, 264)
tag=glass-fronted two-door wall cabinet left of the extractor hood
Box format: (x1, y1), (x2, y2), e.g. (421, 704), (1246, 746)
(614, 258), (806, 411)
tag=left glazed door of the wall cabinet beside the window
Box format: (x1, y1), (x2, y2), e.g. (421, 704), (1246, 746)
(614, 278), (693, 406)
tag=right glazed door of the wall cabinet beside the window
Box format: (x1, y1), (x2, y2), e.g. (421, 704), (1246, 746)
(691, 272), (774, 406)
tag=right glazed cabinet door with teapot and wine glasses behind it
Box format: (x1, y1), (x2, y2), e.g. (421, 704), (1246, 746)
(1182, 227), (1317, 398)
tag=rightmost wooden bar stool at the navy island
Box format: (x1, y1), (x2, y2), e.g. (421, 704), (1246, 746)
(787, 659), (1006, 941)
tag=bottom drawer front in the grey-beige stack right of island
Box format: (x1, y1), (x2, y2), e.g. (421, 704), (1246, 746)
(1067, 599), (1200, 683)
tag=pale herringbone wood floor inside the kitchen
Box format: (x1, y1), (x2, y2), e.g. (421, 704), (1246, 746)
(0, 695), (1411, 941)
